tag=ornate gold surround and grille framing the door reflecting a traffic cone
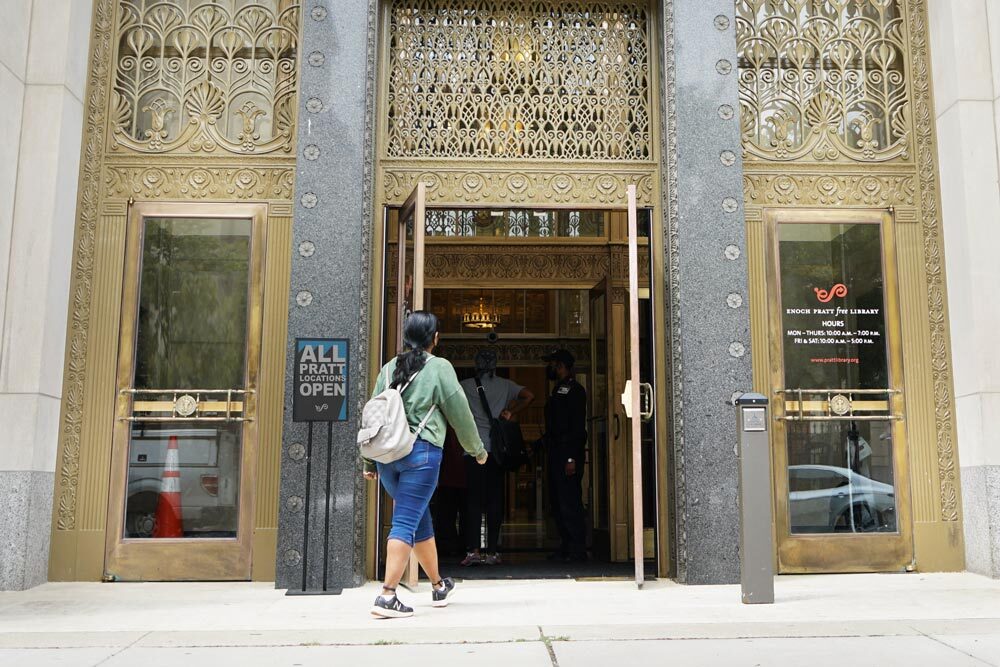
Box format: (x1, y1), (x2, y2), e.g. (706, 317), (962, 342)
(50, 0), (301, 580)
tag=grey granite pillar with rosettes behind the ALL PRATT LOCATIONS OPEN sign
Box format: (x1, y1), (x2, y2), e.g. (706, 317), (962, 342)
(276, 0), (376, 591)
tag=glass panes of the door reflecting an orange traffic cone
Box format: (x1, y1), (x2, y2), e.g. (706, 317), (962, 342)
(124, 218), (252, 538)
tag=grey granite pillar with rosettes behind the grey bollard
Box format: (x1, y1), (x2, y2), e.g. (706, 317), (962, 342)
(663, 0), (752, 584)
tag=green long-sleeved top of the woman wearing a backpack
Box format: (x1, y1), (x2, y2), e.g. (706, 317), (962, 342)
(365, 354), (486, 470)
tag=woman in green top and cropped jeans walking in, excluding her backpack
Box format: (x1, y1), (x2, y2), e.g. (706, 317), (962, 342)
(364, 310), (488, 618)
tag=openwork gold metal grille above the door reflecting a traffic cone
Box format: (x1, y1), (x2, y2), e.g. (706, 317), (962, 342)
(111, 0), (299, 154)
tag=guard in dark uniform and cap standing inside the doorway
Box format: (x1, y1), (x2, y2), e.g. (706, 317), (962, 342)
(542, 350), (587, 561)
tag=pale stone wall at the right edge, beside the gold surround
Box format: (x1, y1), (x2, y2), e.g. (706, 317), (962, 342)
(928, 0), (1000, 577)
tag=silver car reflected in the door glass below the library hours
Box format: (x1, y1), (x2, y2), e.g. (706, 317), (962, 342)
(788, 465), (896, 533)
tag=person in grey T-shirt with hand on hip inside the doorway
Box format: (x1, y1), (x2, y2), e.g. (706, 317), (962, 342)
(462, 349), (535, 566)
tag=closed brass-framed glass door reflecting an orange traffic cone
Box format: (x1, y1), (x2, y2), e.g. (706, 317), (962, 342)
(105, 203), (267, 581)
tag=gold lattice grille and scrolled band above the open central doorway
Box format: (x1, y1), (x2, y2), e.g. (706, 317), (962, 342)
(379, 0), (658, 207)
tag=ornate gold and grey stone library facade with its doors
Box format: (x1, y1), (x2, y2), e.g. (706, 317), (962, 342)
(0, 0), (1000, 591)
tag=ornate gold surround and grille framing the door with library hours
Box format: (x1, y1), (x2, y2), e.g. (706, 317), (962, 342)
(735, 0), (963, 569)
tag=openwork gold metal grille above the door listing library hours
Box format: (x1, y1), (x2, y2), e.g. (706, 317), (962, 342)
(736, 0), (910, 162)
